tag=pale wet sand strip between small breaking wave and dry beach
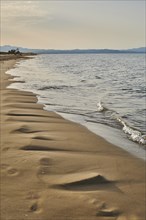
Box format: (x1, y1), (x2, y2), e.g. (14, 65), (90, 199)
(56, 111), (146, 161)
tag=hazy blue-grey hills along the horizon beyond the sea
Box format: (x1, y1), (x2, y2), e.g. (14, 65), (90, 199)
(0, 45), (146, 54)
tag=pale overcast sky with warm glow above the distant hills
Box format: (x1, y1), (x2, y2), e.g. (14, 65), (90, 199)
(1, 0), (145, 49)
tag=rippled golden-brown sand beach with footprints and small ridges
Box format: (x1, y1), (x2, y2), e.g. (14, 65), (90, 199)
(0, 59), (146, 220)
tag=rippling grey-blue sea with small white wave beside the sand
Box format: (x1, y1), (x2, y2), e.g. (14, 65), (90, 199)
(8, 54), (146, 158)
